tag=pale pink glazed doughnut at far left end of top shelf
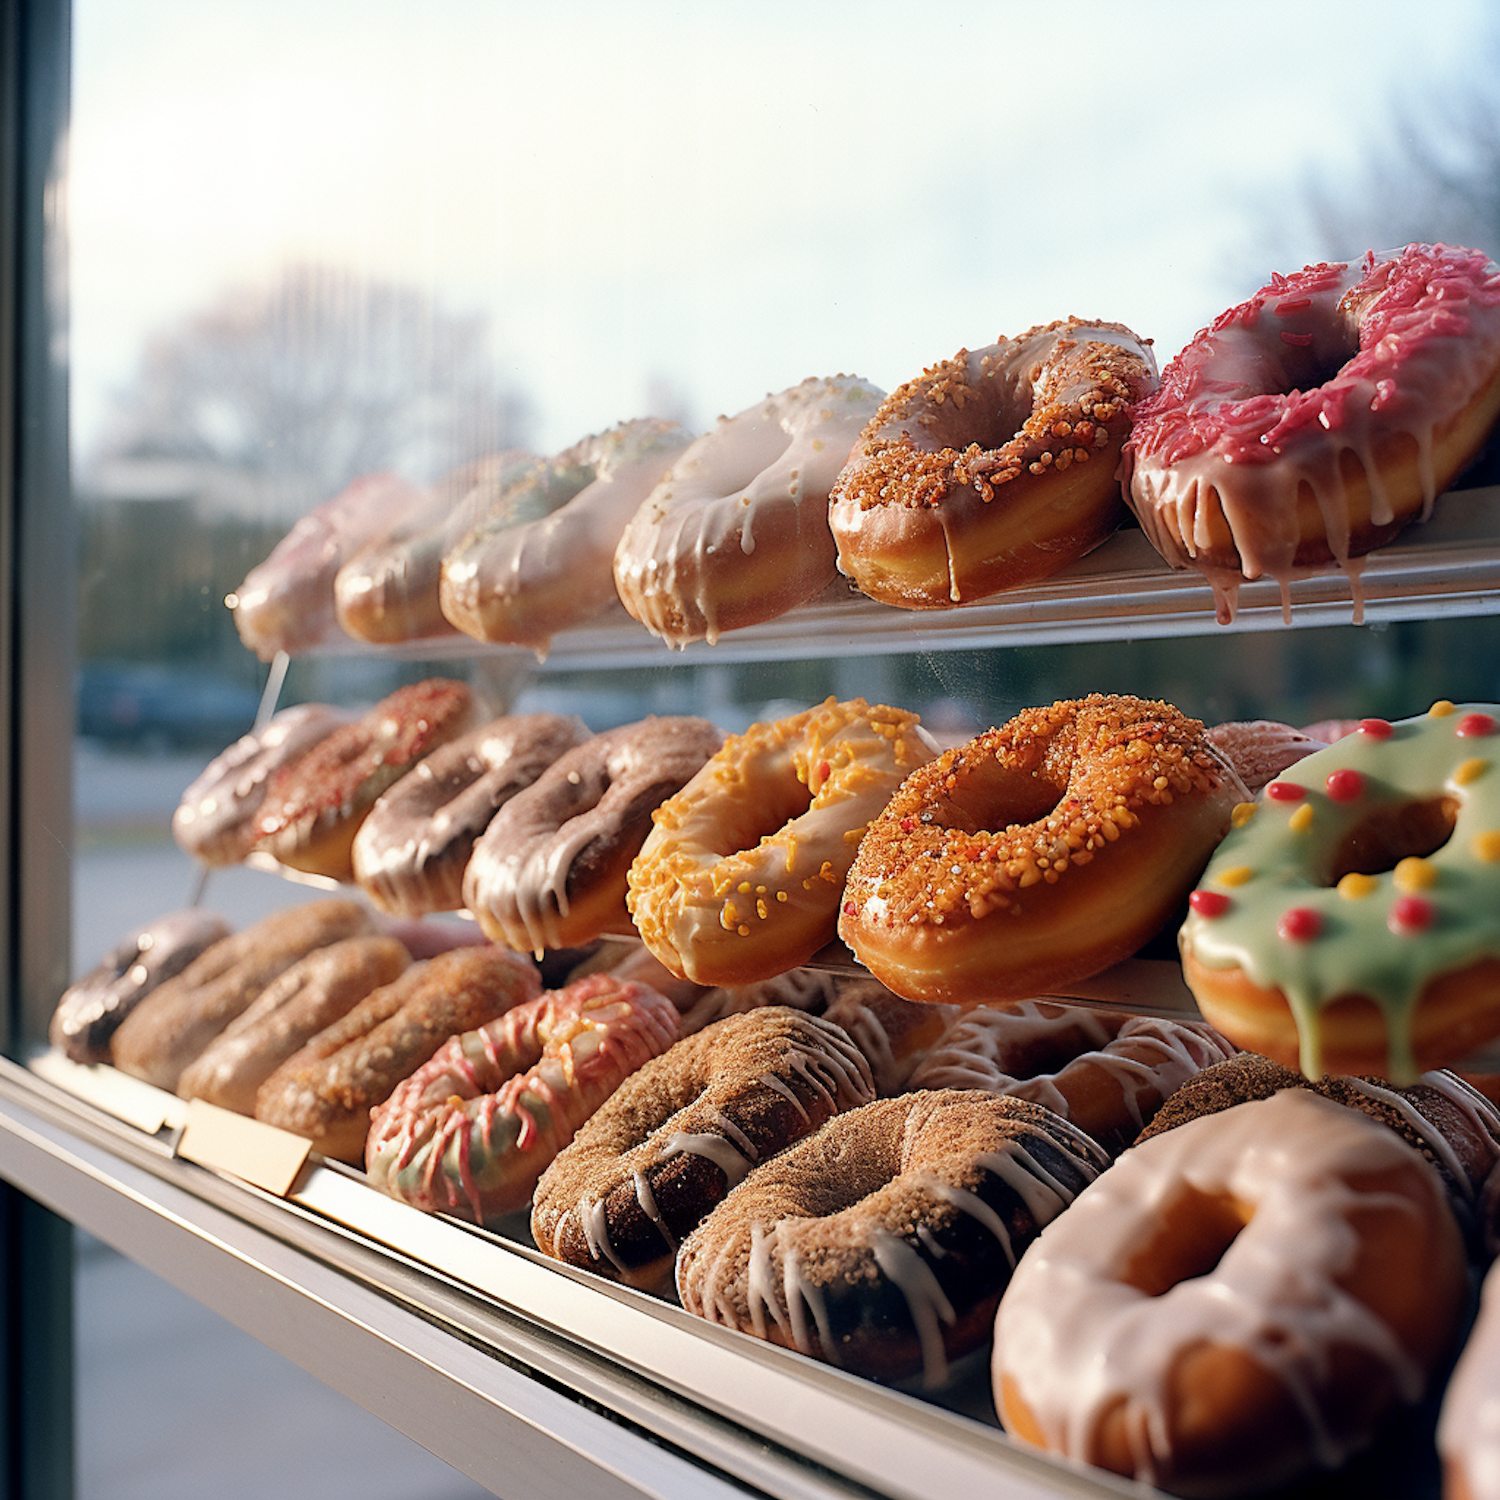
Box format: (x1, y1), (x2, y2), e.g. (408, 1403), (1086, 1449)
(225, 474), (431, 662)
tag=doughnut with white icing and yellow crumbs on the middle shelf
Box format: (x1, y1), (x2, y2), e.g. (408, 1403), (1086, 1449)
(627, 698), (932, 984)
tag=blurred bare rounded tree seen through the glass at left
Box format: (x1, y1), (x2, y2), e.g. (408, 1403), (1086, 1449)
(89, 266), (528, 506)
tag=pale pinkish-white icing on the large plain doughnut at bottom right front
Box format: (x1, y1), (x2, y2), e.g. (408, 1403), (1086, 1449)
(995, 1089), (1463, 1484)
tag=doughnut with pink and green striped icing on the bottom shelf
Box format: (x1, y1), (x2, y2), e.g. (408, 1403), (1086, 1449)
(365, 974), (677, 1224)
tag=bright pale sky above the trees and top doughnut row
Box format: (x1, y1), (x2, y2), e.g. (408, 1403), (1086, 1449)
(71, 0), (1487, 462)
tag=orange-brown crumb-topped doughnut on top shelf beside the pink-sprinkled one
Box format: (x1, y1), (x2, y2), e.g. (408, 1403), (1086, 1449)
(828, 318), (1157, 609)
